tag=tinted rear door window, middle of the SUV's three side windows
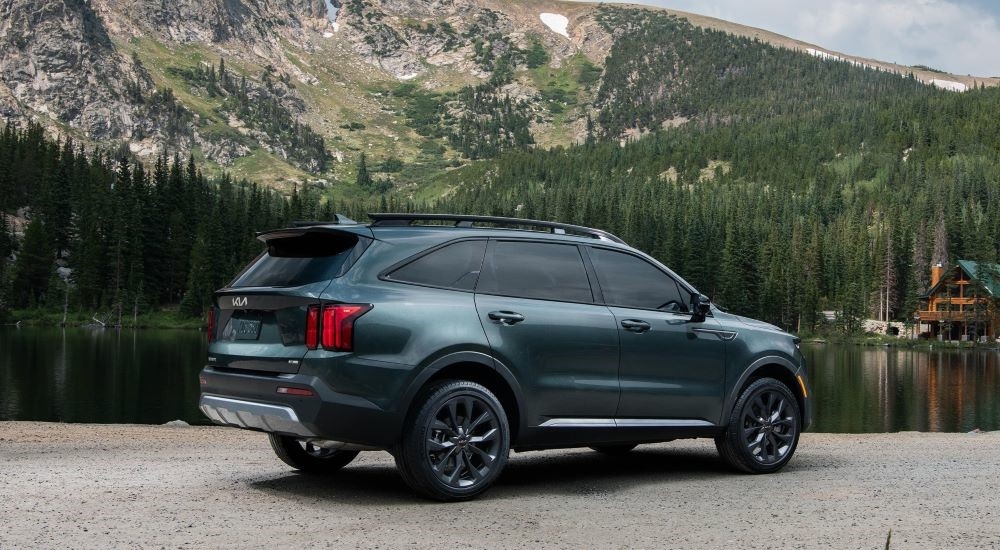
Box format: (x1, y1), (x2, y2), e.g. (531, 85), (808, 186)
(476, 241), (594, 302)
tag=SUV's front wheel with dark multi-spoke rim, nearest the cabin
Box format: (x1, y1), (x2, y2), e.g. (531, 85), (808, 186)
(715, 378), (802, 474)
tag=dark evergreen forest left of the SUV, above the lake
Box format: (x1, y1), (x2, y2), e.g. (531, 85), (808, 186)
(0, 124), (346, 324)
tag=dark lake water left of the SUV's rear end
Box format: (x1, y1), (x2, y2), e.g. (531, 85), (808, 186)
(0, 328), (205, 424)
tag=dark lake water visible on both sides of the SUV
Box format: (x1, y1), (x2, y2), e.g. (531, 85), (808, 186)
(0, 327), (1000, 432)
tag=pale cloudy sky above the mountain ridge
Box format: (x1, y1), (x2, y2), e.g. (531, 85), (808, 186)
(580, 0), (1000, 76)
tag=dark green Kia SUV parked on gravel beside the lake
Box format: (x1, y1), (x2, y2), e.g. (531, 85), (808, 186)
(200, 214), (810, 500)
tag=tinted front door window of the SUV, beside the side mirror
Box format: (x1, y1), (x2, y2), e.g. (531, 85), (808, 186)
(590, 248), (691, 312)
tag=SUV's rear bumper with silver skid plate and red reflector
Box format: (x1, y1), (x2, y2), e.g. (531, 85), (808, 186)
(199, 366), (403, 449)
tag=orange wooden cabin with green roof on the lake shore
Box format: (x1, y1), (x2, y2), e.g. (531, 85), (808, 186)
(914, 260), (1000, 341)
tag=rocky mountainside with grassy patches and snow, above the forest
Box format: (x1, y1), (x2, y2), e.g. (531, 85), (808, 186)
(0, 0), (997, 195)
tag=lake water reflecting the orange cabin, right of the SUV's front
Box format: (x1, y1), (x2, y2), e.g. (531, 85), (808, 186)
(803, 345), (1000, 433)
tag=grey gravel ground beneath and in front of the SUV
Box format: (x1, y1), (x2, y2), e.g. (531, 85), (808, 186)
(0, 422), (1000, 550)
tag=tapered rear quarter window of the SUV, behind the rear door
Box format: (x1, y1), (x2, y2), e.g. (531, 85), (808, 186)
(388, 241), (486, 290)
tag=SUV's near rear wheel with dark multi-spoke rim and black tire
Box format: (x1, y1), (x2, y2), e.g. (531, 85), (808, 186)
(394, 380), (510, 501)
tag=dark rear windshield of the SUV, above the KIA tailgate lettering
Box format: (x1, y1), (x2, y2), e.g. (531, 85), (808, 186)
(229, 232), (368, 288)
